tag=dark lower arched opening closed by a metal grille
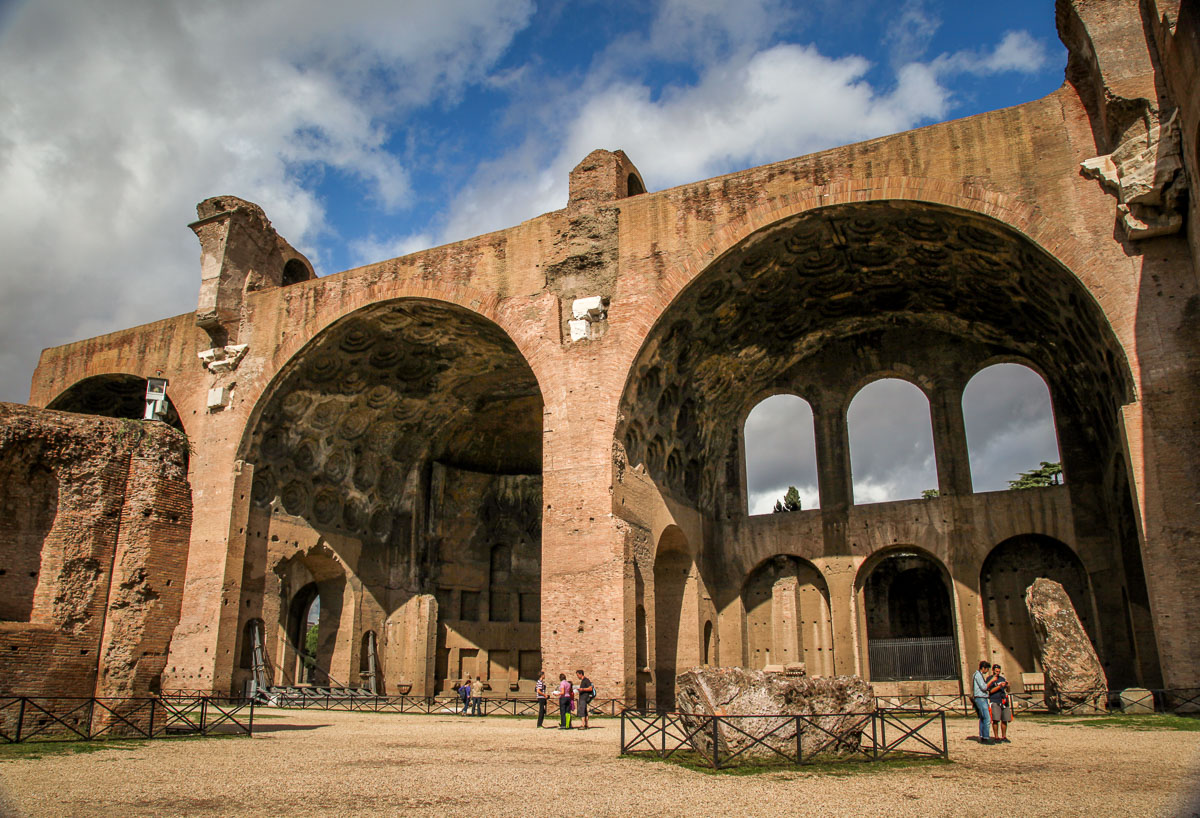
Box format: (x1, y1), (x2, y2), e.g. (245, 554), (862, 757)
(859, 549), (959, 681)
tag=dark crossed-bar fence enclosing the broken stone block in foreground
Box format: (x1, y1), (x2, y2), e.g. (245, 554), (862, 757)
(620, 710), (949, 769)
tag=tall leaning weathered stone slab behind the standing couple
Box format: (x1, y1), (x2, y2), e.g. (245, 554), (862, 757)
(1025, 577), (1109, 711)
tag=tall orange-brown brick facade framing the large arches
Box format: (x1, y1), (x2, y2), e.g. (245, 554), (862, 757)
(16, 0), (1200, 699)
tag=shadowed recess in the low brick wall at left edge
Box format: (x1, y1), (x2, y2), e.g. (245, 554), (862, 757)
(0, 458), (61, 622)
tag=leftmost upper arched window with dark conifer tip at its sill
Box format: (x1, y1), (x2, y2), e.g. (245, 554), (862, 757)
(745, 395), (821, 515)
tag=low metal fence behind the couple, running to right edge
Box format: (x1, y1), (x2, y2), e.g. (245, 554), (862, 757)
(875, 687), (1200, 716)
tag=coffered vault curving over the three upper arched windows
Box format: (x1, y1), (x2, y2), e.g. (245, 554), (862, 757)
(613, 188), (1133, 516)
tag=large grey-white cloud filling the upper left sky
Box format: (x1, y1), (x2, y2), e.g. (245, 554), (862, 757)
(0, 0), (532, 399)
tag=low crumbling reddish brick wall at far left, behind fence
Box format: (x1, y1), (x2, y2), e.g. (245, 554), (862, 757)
(0, 404), (191, 696)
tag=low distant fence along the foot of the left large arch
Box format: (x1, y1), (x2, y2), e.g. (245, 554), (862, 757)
(163, 688), (625, 717)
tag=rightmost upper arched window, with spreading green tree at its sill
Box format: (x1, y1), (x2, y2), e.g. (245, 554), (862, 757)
(962, 363), (1061, 492)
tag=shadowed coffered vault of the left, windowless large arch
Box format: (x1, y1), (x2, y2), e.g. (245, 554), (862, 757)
(232, 288), (542, 545)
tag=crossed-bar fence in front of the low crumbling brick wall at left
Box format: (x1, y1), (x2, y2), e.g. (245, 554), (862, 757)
(0, 696), (254, 744)
